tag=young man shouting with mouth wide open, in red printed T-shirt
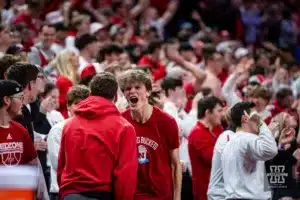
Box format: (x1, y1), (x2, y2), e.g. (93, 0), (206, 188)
(119, 69), (182, 200)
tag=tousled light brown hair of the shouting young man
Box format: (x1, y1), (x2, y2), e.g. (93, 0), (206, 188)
(119, 69), (152, 91)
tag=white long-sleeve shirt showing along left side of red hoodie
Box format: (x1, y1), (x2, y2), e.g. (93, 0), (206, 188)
(47, 119), (68, 193)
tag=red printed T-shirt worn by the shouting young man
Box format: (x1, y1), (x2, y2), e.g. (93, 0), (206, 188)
(123, 107), (179, 200)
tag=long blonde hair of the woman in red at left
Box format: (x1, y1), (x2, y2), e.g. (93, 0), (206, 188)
(49, 50), (79, 84)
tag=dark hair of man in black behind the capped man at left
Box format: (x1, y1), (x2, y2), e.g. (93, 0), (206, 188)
(6, 63), (40, 88)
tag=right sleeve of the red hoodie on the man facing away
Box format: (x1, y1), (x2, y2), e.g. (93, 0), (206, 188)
(114, 125), (138, 200)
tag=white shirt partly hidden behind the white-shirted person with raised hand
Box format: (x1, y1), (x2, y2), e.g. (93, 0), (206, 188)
(207, 130), (234, 200)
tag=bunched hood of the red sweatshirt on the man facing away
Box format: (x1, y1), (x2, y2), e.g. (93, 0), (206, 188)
(75, 96), (120, 119)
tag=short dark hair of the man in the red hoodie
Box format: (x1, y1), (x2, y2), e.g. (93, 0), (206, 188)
(90, 72), (118, 100)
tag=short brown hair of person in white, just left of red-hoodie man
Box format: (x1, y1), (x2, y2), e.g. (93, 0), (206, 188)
(67, 85), (90, 106)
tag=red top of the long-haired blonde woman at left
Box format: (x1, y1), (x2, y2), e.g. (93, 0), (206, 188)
(56, 76), (73, 118)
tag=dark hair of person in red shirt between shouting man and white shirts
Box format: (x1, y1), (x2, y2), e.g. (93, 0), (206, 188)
(197, 96), (223, 119)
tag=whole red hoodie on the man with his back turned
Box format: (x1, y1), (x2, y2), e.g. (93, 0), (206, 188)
(57, 96), (138, 200)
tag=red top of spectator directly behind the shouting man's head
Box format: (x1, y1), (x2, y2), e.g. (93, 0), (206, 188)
(138, 56), (167, 81)
